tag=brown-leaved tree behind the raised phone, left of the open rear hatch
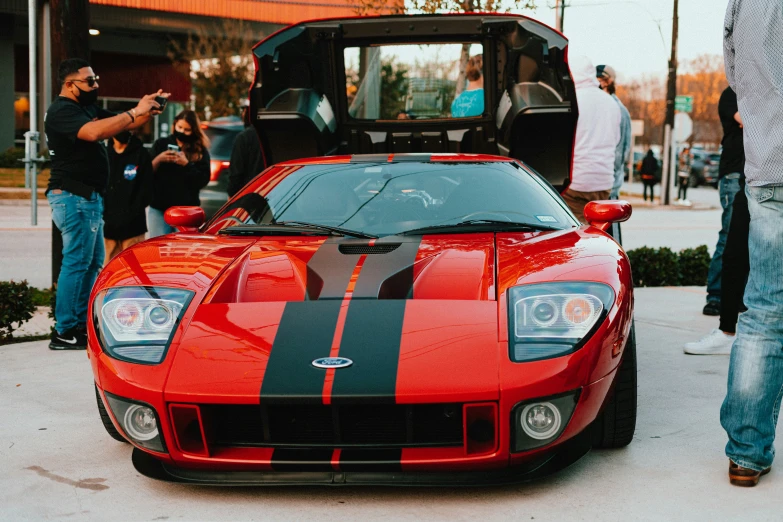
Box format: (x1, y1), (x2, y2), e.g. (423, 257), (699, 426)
(169, 19), (263, 119)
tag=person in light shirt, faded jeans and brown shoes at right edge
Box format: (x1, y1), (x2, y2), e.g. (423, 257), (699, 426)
(720, 0), (783, 486)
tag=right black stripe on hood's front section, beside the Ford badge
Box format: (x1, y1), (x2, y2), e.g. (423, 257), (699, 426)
(332, 299), (406, 403)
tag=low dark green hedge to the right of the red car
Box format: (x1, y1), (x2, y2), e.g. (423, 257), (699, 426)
(626, 245), (712, 287)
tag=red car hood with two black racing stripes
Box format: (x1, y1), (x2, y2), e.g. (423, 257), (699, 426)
(166, 233), (498, 404)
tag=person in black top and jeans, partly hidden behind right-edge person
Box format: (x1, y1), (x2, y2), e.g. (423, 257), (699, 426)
(703, 87), (745, 315)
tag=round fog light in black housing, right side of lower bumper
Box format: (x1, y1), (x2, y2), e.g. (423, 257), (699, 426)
(511, 390), (579, 451)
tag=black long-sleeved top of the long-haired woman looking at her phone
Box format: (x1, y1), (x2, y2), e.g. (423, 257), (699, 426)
(150, 136), (209, 210)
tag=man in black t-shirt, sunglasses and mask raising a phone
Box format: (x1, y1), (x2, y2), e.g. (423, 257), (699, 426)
(44, 58), (168, 350)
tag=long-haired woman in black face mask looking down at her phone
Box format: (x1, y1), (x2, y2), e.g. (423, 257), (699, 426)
(149, 110), (209, 237)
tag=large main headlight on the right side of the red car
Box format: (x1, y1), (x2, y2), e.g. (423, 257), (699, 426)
(508, 282), (614, 362)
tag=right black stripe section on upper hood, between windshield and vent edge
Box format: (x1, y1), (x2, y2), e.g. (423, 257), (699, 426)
(353, 236), (421, 299)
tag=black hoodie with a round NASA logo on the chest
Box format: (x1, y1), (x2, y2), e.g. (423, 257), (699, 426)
(103, 136), (152, 241)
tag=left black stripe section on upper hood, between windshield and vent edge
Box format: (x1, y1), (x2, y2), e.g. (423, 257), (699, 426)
(306, 238), (361, 296)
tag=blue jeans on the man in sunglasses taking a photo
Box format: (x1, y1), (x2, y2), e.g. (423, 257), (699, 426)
(47, 190), (104, 333)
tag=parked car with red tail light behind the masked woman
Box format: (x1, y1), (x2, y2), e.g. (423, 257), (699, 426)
(200, 116), (245, 217)
